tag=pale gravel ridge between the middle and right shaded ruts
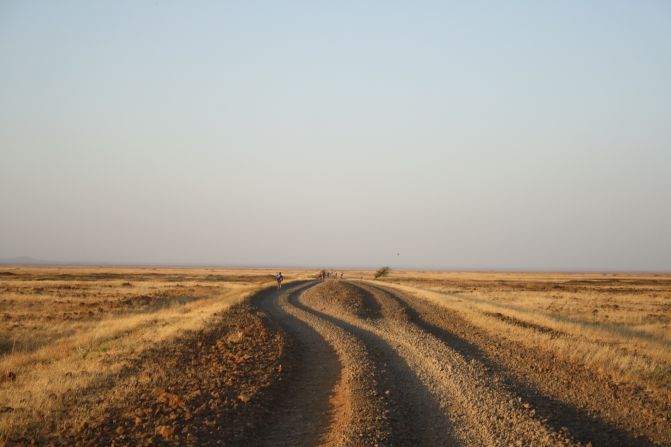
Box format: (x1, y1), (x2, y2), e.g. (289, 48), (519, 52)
(320, 287), (574, 445)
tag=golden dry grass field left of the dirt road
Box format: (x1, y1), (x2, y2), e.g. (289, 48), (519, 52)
(0, 267), (312, 445)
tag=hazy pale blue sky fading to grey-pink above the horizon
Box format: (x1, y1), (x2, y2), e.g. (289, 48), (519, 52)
(0, 0), (671, 270)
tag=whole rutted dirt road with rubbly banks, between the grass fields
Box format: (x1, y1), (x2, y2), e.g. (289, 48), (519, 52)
(32, 281), (671, 446)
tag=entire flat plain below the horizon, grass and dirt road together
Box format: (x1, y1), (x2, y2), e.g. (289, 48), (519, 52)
(0, 266), (671, 446)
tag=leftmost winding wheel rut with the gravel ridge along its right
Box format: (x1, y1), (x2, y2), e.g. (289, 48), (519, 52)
(255, 284), (393, 446)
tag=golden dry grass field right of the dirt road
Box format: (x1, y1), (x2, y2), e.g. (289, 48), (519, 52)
(372, 272), (671, 392)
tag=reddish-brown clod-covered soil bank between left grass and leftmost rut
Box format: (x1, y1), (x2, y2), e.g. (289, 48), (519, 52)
(24, 305), (291, 446)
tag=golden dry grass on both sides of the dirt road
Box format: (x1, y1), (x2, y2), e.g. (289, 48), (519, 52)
(0, 266), (671, 445)
